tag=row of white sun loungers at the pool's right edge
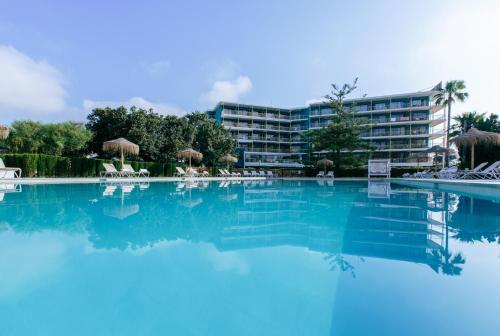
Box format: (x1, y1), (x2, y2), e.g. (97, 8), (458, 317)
(403, 161), (500, 180)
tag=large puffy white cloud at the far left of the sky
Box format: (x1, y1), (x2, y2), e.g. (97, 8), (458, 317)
(0, 45), (66, 115)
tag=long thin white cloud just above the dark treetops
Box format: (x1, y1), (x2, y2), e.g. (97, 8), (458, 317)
(83, 97), (186, 116)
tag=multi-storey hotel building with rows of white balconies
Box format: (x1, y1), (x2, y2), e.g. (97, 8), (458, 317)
(207, 86), (445, 168)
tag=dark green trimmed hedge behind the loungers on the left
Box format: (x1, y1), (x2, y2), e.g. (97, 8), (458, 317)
(0, 154), (179, 177)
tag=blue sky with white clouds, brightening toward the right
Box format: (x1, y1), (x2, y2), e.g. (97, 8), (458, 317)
(0, 0), (500, 124)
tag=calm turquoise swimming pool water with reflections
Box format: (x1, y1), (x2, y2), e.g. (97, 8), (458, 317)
(0, 181), (500, 336)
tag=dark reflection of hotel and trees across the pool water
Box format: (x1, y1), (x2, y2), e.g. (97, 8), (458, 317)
(0, 180), (500, 275)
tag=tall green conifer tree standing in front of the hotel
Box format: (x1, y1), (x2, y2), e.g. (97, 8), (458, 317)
(308, 78), (371, 169)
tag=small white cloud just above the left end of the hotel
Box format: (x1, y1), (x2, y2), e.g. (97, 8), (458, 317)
(201, 76), (252, 104)
